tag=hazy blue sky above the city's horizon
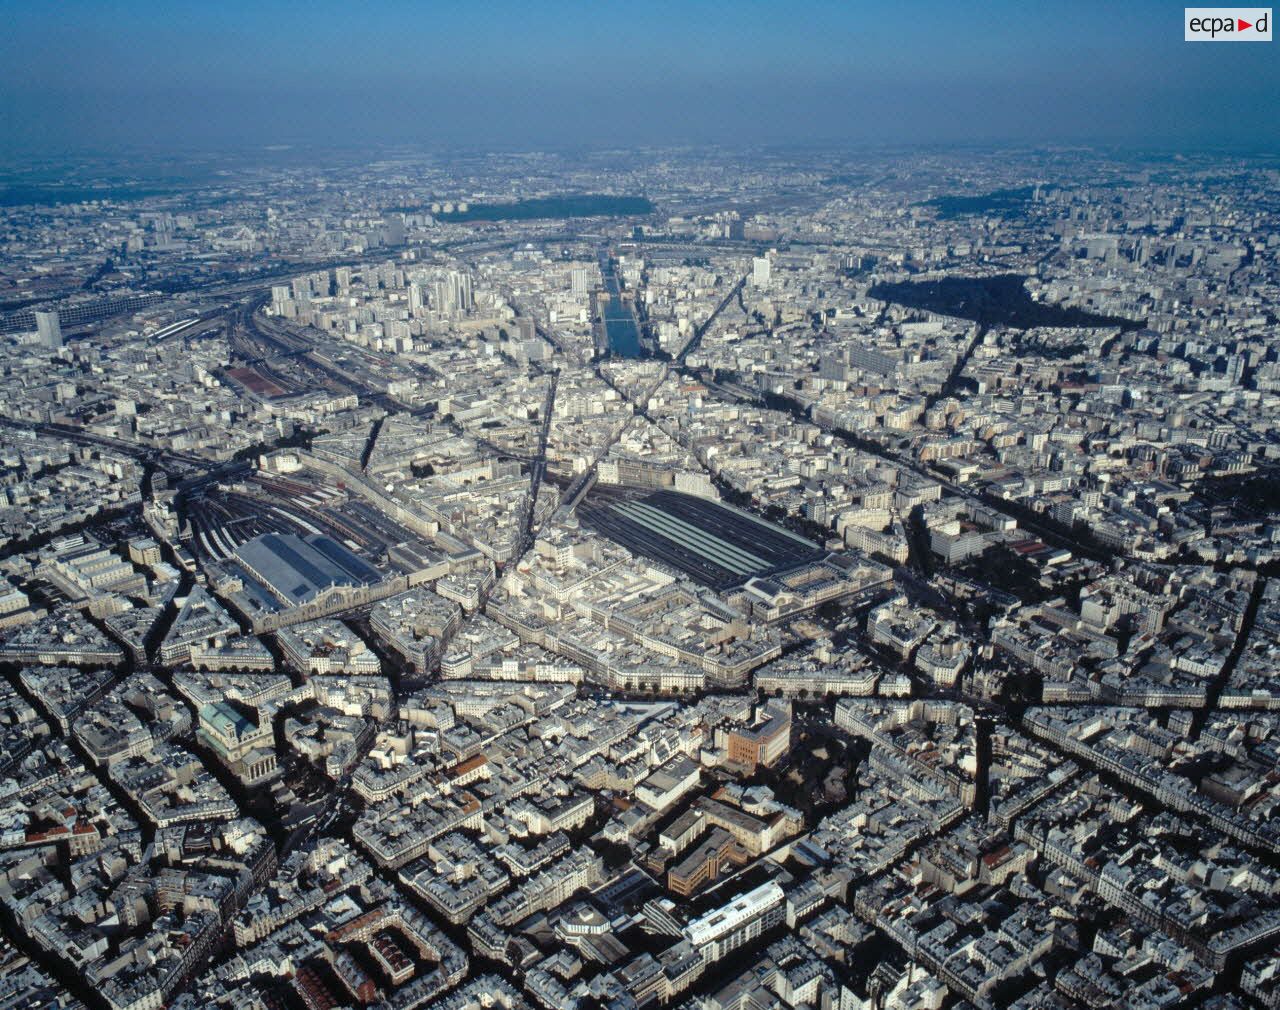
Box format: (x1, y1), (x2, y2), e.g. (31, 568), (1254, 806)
(0, 0), (1280, 151)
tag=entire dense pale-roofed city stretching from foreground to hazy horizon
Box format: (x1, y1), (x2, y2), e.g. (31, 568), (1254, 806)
(0, 147), (1280, 1010)
